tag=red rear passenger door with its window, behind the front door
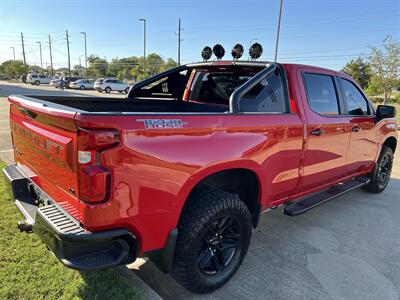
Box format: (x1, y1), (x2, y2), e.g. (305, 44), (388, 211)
(299, 69), (351, 192)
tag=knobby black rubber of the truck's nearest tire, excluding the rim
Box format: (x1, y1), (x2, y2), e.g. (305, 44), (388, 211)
(171, 190), (252, 293)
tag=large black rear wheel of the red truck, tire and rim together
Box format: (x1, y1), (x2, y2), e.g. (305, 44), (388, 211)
(172, 190), (252, 293)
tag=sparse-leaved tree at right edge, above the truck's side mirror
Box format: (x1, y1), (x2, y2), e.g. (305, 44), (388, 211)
(367, 36), (400, 104)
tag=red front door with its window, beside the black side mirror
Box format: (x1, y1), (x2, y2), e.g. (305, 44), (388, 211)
(339, 77), (379, 173)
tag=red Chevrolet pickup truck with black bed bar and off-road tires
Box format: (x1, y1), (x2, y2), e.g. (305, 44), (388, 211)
(4, 61), (397, 293)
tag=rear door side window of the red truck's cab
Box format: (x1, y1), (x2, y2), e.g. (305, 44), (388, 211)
(304, 73), (340, 115)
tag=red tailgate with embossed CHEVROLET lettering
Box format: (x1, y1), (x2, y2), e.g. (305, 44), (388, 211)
(9, 96), (79, 219)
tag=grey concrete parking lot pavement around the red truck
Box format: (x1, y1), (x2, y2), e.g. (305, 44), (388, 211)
(0, 83), (400, 299)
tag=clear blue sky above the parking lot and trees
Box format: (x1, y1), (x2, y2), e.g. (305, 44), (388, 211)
(0, 0), (400, 70)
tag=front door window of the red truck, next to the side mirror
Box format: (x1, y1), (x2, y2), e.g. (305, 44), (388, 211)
(340, 78), (370, 116)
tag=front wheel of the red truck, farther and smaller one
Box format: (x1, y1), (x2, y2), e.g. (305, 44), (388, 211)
(362, 146), (393, 193)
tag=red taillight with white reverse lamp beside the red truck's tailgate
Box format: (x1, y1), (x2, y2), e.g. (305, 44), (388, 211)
(78, 129), (118, 204)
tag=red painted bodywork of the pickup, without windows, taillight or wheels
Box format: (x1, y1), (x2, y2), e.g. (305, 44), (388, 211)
(10, 65), (397, 253)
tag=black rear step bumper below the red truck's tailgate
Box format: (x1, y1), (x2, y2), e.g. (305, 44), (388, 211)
(3, 165), (137, 271)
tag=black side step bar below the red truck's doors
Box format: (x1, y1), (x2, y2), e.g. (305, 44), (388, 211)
(282, 177), (370, 217)
